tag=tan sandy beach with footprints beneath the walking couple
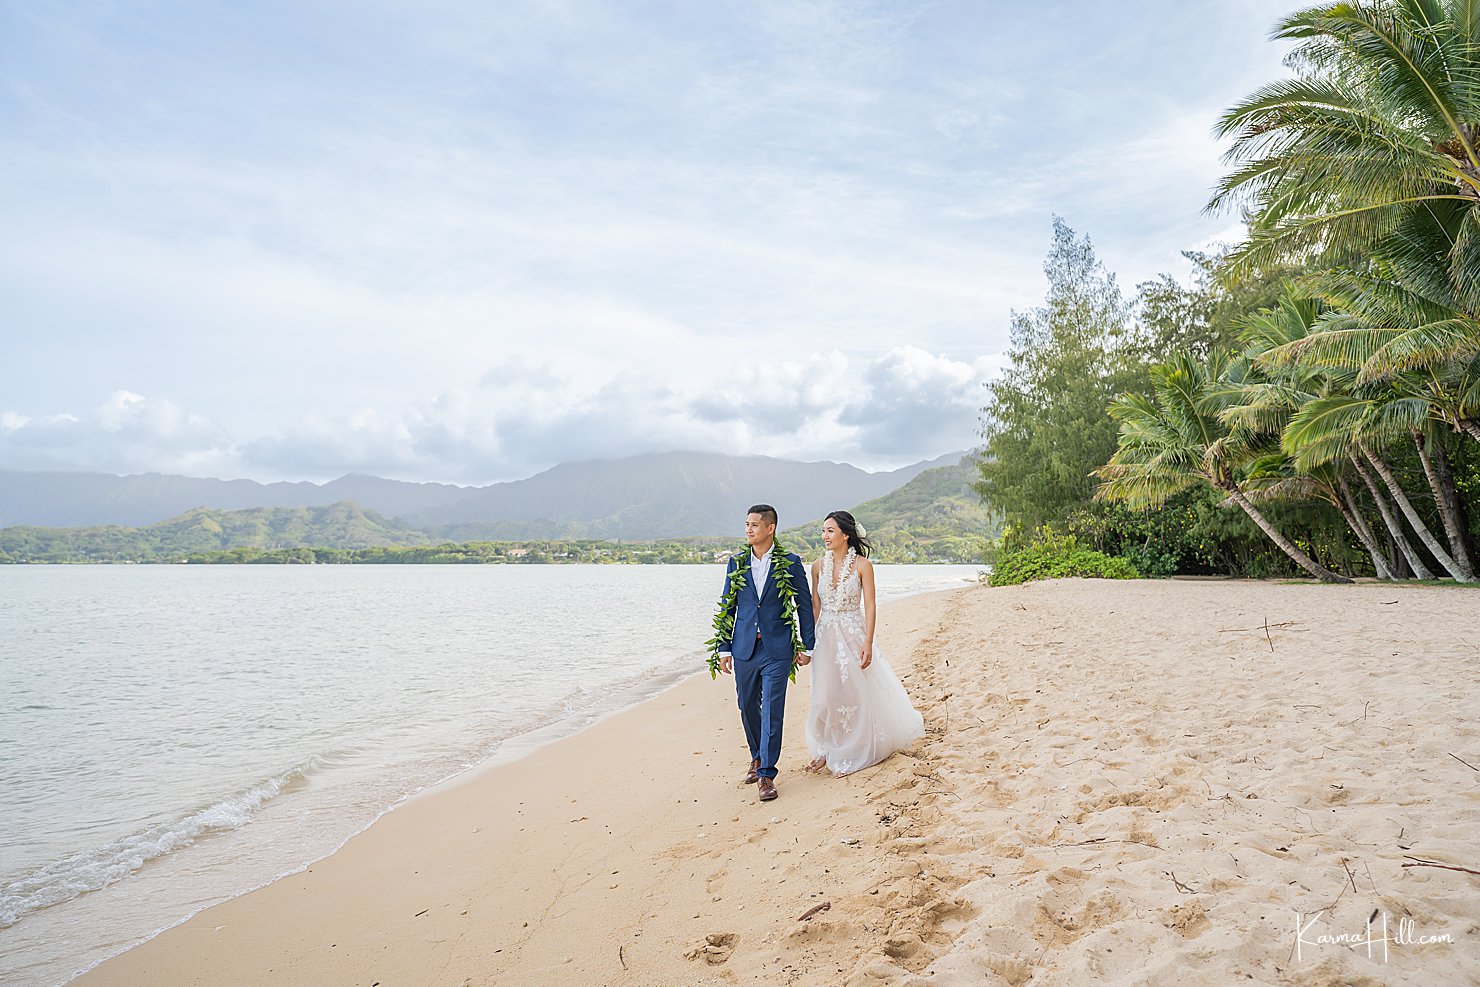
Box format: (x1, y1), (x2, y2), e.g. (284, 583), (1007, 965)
(75, 580), (1480, 987)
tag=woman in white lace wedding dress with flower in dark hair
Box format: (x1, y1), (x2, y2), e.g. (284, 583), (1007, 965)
(807, 511), (925, 777)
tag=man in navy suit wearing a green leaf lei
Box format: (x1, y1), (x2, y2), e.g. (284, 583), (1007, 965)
(719, 503), (814, 802)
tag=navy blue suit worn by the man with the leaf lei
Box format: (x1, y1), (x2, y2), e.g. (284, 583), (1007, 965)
(719, 549), (815, 778)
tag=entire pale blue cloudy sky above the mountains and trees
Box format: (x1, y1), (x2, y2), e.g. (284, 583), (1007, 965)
(0, 0), (1298, 482)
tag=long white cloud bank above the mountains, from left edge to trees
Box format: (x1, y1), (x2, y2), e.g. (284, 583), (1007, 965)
(0, 346), (1000, 484)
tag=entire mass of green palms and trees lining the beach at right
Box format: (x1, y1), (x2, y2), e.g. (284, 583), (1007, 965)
(980, 0), (1480, 583)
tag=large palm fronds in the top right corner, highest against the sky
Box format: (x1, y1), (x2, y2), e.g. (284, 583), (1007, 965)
(1209, 0), (1480, 320)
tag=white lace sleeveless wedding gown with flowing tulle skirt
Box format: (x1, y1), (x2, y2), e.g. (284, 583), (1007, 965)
(807, 549), (925, 774)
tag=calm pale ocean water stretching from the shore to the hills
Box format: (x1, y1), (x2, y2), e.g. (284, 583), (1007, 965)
(0, 565), (977, 986)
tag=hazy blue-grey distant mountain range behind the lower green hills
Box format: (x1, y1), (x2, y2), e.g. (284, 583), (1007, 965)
(0, 453), (961, 542)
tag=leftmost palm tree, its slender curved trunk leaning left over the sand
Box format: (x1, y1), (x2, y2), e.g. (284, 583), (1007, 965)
(1092, 352), (1351, 583)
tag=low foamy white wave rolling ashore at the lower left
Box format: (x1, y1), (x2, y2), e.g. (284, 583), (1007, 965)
(0, 755), (337, 928)
